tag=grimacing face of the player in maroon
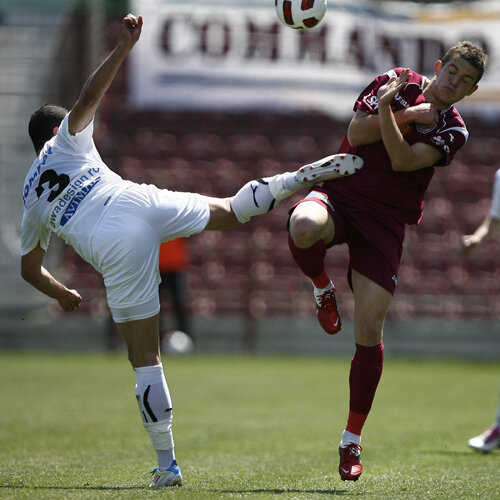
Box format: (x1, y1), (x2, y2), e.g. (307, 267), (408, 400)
(433, 56), (479, 109)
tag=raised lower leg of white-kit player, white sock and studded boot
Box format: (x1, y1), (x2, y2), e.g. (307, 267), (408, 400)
(231, 154), (363, 223)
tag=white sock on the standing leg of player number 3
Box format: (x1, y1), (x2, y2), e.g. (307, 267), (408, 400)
(134, 364), (175, 469)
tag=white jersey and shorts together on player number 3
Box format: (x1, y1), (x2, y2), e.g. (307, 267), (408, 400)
(21, 111), (210, 323)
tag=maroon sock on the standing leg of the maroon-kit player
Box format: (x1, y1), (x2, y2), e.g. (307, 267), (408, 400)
(346, 342), (384, 435)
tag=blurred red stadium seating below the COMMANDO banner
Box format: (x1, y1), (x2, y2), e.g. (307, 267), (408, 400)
(65, 97), (500, 318)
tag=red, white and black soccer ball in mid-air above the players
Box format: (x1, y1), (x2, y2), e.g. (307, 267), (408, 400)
(274, 0), (327, 30)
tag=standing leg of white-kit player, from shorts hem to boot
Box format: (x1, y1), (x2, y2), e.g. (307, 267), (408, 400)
(117, 314), (182, 488)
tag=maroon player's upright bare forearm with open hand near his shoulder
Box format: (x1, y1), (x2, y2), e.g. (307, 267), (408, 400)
(377, 69), (441, 172)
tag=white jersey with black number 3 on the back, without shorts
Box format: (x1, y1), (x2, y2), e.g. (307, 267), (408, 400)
(21, 114), (132, 260)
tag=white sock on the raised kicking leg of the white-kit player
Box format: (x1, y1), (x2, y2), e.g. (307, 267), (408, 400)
(231, 172), (305, 223)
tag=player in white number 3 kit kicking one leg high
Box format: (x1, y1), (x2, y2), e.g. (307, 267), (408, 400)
(21, 14), (363, 487)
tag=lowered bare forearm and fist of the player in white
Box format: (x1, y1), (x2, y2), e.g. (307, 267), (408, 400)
(21, 245), (82, 312)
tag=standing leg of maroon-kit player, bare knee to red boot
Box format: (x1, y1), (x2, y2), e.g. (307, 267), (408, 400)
(339, 271), (392, 481)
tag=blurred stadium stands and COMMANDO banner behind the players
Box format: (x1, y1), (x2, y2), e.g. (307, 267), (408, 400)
(0, 0), (500, 359)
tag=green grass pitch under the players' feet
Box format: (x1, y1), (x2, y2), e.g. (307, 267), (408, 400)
(0, 353), (500, 500)
